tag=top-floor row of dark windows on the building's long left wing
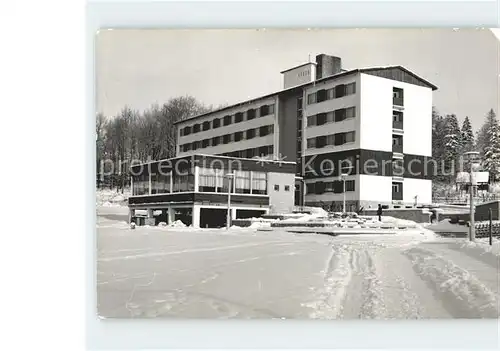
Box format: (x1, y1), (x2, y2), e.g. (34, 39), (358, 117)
(180, 104), (274, 136)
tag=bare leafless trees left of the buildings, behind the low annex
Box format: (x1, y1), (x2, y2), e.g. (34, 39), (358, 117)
(96, 96), (224, 191)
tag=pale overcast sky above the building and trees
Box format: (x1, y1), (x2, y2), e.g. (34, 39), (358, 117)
(96, 29), (500, 129)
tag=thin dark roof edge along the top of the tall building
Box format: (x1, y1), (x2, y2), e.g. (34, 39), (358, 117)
(173, 65), (438, 125)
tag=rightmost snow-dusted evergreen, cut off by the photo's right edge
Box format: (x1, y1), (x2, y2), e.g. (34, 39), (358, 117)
(482, 109), (500, 182)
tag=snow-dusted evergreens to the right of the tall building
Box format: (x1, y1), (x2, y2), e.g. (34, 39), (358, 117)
(432, 108), (500, 184)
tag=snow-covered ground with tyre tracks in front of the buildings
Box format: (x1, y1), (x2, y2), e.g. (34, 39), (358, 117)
(97, 207), (500, 319)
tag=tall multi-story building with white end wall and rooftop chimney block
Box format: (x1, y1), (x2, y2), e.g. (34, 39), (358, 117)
(177, 54), (437, 210)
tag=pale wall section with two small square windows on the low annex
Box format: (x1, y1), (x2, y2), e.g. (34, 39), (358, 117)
(267, 172), (295, 213)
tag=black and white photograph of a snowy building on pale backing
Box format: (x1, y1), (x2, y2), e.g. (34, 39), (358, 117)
(94, 28), (500, 320)
